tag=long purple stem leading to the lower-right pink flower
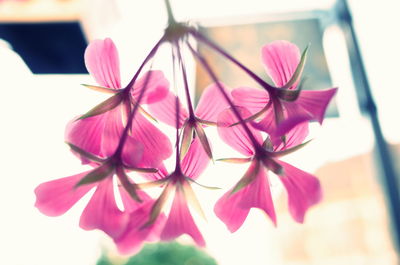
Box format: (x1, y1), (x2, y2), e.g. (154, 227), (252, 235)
(186, 42), (260, 148)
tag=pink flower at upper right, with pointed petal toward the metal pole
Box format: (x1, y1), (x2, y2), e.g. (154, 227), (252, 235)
(232, 40), (337, 144)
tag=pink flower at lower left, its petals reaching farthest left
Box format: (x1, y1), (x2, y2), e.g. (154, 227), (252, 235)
(35, 138), (164, 239)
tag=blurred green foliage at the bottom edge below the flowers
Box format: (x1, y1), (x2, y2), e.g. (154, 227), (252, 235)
(97, 242), (217, 265)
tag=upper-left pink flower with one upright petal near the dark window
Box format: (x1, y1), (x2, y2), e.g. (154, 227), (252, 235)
(65, 38), (172, 167)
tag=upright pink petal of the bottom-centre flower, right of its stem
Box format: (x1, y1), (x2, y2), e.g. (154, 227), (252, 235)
(181, 138), (210, 179)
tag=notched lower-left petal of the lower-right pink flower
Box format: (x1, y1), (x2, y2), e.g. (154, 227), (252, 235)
(214, 162), (276, 233)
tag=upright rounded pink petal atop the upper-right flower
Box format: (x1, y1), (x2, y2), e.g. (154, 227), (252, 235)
(261, 40), (300, 89)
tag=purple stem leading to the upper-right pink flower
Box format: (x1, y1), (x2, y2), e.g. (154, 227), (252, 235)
(189, 29), (275, 93)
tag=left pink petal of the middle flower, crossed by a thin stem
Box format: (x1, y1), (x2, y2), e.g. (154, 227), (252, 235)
(149, 92), (189, 127)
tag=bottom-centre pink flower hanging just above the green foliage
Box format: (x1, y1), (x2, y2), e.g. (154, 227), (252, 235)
(115, 138), (209, 250)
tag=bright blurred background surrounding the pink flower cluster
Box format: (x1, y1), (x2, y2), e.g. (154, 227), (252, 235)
(0, 0), (400, 265)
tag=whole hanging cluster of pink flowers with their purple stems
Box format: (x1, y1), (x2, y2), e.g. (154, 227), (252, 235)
(35, 13), (336, 253)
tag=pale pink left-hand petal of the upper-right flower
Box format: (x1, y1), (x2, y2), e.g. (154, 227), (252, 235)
(232, 87), (269, 112)
